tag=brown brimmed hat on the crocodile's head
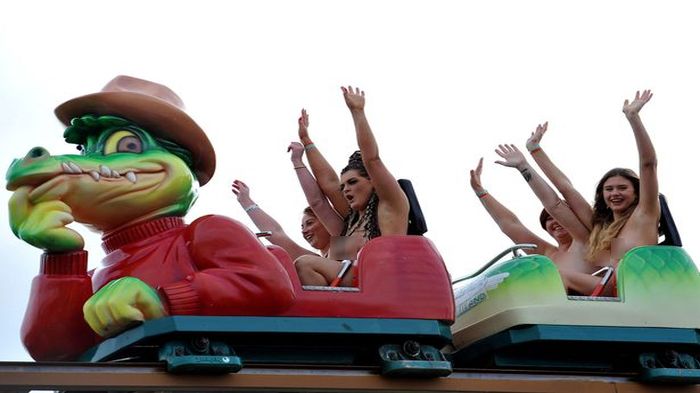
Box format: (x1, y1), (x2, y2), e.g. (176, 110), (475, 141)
(54, 75), (216, 185)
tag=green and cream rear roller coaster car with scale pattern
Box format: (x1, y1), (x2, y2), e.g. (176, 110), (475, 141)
(448, 196), (700, 383)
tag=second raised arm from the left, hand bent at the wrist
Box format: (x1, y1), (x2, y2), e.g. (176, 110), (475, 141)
(287, 142), (344, 236)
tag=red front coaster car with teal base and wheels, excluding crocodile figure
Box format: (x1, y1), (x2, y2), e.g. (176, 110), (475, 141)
(81, 180), (455, 376)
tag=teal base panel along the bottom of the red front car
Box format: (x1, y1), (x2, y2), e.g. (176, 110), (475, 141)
(80, 316), (452, 363)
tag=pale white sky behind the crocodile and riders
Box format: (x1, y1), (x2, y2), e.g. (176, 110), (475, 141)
(0, 0), (700, 360)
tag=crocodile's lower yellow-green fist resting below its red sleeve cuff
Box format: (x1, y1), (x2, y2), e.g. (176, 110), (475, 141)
(83, 277), (166, 337)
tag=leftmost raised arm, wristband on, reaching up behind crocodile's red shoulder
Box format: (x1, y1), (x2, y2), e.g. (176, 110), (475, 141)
(231, 180), (317, 260)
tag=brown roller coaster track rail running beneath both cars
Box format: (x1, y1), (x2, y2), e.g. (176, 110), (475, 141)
(0, 362), (700, 393)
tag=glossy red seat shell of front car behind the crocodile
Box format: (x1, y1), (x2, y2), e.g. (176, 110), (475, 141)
(267, 235), (455, 323)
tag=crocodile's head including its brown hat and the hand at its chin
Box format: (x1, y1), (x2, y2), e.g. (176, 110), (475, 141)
(6, 75), (216, 245)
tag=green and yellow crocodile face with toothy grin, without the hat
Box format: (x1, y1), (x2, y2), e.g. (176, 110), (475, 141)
(6, 115), (198, 232)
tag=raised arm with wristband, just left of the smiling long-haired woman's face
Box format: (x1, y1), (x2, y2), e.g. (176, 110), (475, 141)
(526, 122), (593, 231)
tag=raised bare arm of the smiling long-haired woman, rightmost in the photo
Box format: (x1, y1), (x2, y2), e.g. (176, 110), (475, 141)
(622, 90), (661, 220)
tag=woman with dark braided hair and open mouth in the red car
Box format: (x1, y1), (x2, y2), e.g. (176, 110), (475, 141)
(295, 86), (409, 286)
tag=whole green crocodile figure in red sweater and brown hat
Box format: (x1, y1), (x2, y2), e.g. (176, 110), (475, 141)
(6, 76), (294, 360)
